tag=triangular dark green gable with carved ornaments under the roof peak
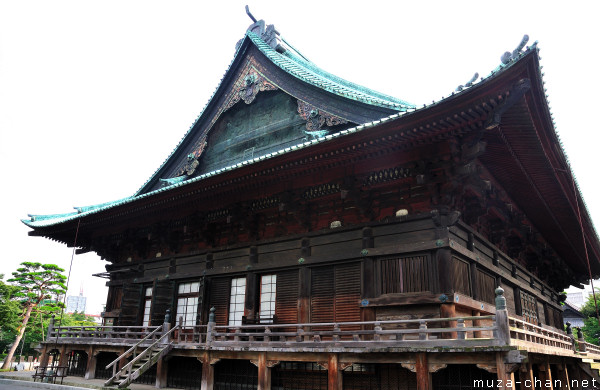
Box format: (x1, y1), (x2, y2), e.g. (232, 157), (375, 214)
(138, 32), (406, 195)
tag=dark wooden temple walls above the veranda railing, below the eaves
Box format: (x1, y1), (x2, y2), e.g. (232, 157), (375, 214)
(108, 215), (561, 327)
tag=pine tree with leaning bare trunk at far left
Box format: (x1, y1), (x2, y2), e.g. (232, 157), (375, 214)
(2, 262), (67, 369)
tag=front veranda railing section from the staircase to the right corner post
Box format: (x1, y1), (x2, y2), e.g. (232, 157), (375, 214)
(206, 316), (498, 350)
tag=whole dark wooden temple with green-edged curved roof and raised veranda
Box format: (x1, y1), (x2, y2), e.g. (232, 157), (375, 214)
(23, 12), (600, 390)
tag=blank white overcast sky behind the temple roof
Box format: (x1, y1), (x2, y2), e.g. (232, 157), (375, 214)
(0, 0), (600, 314)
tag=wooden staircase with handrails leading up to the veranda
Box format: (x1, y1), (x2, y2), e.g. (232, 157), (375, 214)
(104, 326), (178, 389)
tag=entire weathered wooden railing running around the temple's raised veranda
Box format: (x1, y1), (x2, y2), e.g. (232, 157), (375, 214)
(43, 288), (600, 356)
